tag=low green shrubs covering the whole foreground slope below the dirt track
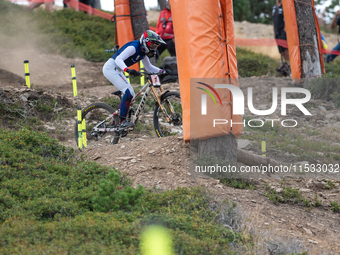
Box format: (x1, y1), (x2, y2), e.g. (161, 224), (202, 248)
(0, 129), (249, 254)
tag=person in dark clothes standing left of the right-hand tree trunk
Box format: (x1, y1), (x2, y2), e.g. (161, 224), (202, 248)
(272, 0), (290, 76)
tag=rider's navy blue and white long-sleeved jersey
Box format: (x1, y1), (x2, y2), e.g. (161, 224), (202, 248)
(111, 40), (161, 72)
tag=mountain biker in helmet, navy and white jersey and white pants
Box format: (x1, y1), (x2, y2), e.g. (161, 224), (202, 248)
(103, 30), (166, 129)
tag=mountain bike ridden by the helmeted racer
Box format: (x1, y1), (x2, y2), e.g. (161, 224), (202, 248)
(74, 71), (183, 147)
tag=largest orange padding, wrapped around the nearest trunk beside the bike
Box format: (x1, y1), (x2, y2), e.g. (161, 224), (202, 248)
(170, 0), (243, 142)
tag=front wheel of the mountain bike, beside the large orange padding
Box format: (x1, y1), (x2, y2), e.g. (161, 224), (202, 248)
(153, 91), (183, 137)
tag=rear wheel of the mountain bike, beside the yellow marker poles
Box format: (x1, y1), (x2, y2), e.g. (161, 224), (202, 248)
(74, 103), (119, 148)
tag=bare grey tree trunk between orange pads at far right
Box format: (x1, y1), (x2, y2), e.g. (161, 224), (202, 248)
(295, 0), (322, 84)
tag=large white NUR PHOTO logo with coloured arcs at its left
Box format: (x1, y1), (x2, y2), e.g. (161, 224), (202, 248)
(196, 82), (312, 127)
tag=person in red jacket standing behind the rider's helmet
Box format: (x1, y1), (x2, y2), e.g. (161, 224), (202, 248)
(156, 1), (176, 59)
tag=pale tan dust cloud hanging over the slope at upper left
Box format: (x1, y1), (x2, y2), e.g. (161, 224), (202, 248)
(0, 3), (77, 87)
